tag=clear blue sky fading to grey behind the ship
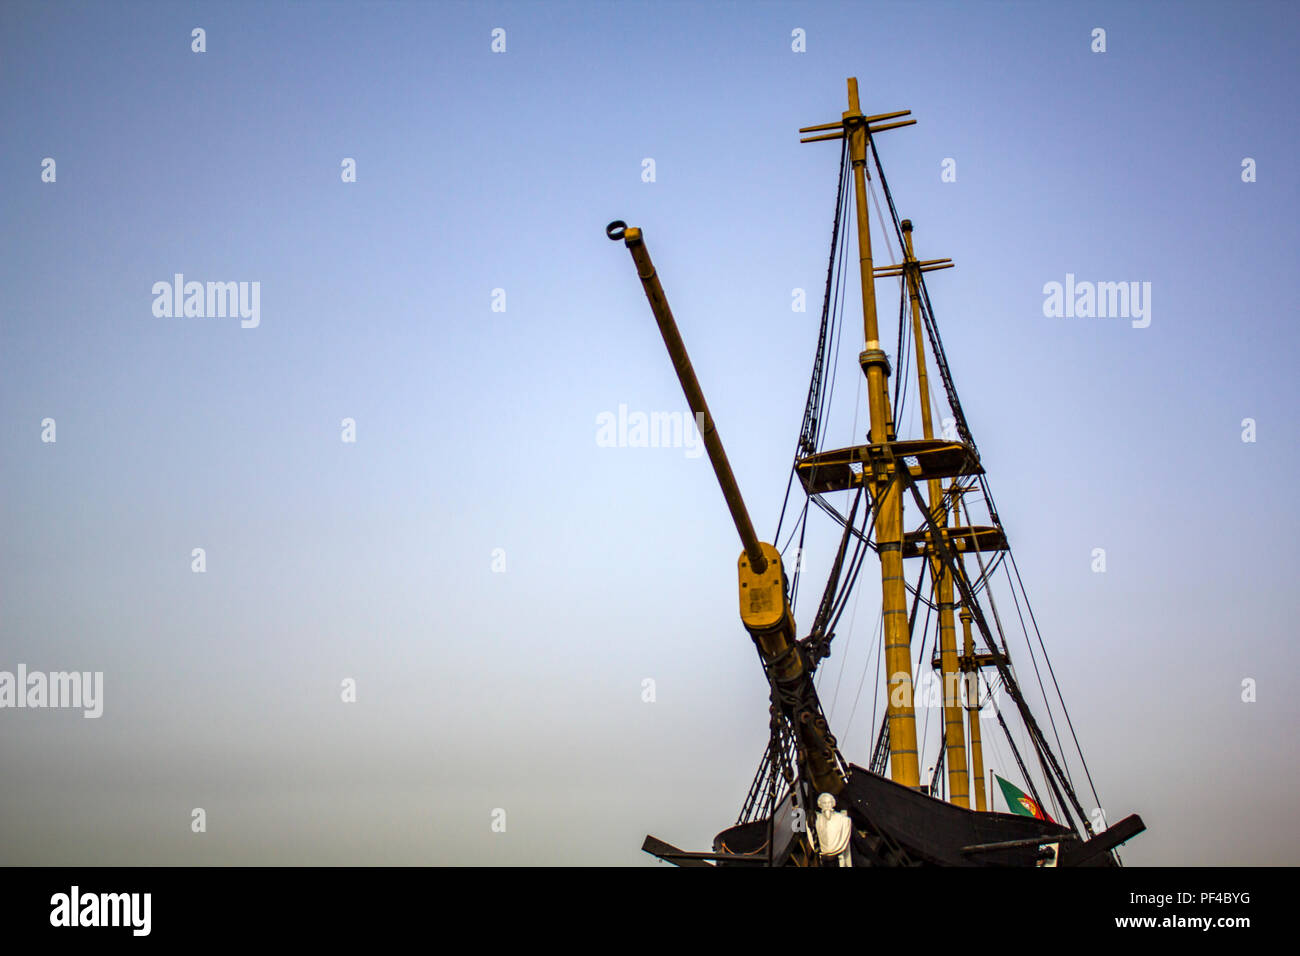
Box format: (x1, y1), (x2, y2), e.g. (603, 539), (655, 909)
(0, 3), (1300, 866)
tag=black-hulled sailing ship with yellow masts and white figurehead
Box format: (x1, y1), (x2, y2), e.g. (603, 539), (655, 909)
(606, 78), (1144, 866)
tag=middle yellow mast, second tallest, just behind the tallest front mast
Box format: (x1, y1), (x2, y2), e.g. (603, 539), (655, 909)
(902, 219), (970, 806)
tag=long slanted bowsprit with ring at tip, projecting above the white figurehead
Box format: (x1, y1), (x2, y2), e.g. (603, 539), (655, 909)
(605, 221), (845, 795)
